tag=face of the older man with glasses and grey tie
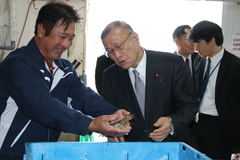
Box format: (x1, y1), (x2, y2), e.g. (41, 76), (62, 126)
(102, 28), (143, 69)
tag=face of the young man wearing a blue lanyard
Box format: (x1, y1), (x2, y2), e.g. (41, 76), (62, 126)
(194, 39), (215, 58)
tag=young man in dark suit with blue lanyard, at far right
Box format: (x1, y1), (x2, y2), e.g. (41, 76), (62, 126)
(189, 21), (240, 160)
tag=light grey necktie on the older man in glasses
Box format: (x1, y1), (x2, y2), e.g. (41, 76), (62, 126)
(133, 70), (145, 117)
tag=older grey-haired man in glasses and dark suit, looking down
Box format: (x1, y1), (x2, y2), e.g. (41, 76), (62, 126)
(101, 21), (197, 147)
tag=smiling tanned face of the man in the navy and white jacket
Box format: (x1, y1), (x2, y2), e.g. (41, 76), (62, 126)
(37, 23), (75, 61)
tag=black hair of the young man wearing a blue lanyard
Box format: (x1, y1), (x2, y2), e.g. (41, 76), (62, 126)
(188, 20), (223, 46)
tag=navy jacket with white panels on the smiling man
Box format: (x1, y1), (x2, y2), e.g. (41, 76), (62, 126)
(0, 39), (117, 160)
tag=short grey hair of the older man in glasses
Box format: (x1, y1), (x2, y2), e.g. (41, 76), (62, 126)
(101, 21), (133, 39)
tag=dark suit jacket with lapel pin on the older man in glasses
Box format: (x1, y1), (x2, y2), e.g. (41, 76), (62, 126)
(102, 50), (197, 145)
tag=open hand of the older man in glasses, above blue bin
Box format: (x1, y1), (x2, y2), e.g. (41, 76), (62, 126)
(149, 117), (171, 142)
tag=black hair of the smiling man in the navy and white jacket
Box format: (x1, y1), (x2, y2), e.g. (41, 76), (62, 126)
(34, 1), (81, 36)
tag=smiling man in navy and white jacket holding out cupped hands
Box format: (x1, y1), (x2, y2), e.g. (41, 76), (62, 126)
(0, 2), (130, 160)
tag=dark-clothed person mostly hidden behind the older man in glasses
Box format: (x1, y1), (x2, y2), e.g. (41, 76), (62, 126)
(95, 55), (115, 95)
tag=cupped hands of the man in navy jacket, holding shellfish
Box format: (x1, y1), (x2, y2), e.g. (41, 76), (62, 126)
(88, 109), (131, 136)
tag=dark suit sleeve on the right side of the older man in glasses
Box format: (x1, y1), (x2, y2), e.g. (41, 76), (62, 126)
(170, 57), (197, 135)
